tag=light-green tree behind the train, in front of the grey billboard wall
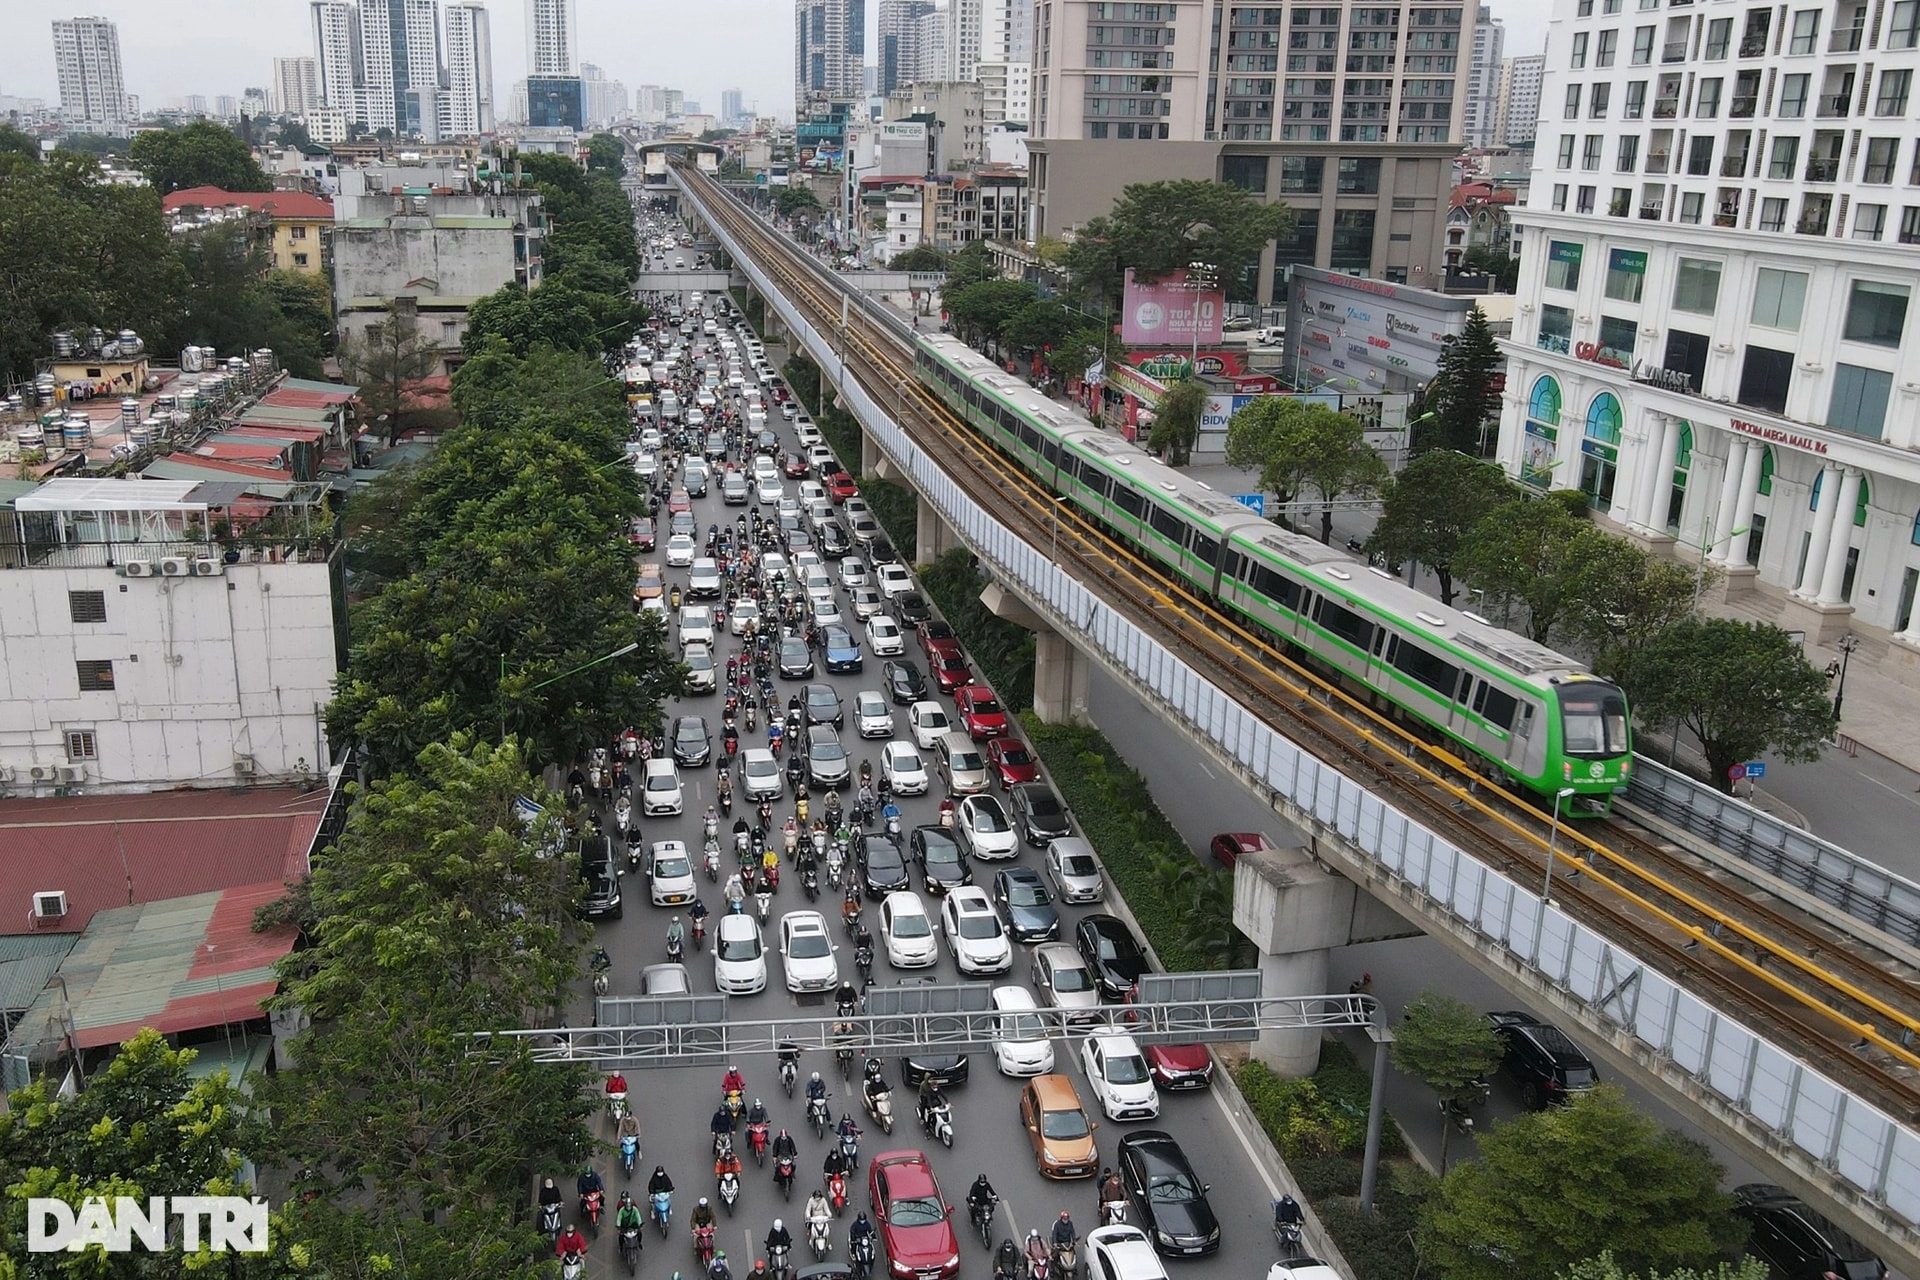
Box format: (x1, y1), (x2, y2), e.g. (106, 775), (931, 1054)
(1227, 395), (1386, 541)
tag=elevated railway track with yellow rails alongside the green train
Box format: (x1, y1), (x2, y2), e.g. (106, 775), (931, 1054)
(682, 169), (1920, 1119)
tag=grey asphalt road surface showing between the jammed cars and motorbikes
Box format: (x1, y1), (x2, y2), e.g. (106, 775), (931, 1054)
(553, 233), (1305, 1280)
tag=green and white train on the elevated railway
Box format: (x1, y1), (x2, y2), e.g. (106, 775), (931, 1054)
(916, 336), (1632, 816)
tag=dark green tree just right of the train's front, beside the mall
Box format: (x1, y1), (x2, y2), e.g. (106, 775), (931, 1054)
(1620, 618), (1839, 791)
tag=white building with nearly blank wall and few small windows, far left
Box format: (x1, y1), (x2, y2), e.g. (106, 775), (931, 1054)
(0, 480), (340, 793)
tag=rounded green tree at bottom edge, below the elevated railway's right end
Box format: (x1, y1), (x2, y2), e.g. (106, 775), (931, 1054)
(1421, 1084), (1743, 1280)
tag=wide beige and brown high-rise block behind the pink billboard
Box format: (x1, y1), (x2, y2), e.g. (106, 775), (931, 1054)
(1027, 0), (1478, 303)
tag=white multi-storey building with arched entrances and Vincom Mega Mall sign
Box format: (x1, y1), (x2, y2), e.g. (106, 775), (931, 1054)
(1500, 0), (1920, 644)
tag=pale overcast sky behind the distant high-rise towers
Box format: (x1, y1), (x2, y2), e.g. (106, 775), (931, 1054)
(0, 0), (1549, 122)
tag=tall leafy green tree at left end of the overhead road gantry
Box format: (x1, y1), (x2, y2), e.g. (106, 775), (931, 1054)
(255, 737), (593, 1280)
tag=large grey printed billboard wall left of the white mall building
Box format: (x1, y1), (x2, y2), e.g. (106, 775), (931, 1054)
(1283, 267), (1473, 395)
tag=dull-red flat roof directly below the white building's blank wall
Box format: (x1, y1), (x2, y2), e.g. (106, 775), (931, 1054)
(0, 786), (326, 933)
